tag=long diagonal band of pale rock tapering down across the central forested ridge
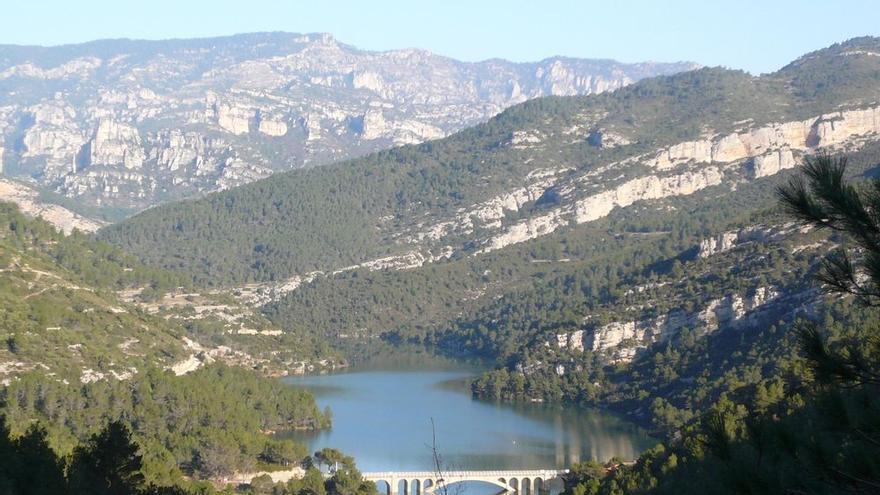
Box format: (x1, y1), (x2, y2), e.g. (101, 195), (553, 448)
(220, 103), (880, 305)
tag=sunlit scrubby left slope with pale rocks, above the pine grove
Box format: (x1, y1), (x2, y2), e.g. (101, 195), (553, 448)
(0, 203), (332, 384)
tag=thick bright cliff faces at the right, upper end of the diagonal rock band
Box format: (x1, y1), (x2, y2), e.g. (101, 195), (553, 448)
(454, 107), (880, 252)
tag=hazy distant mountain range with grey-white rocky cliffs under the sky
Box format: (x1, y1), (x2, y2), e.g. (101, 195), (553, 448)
(0, 33), (697, 221)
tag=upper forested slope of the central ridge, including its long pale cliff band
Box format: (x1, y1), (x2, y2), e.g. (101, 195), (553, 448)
(100, 39), (880, 285)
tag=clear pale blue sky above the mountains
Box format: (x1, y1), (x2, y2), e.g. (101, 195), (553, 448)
(0, 0), (880, 73)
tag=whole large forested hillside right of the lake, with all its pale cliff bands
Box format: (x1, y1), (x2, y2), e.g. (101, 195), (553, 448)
(99, 38), (880, 434)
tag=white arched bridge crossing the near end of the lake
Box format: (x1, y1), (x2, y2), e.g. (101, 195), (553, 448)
(363, 469), (568, 495)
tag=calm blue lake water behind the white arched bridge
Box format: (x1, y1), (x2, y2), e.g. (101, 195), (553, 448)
(285, 357), (655, 471)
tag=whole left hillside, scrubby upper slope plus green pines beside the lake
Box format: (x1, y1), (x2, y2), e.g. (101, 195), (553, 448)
(0, 202), (340, 486)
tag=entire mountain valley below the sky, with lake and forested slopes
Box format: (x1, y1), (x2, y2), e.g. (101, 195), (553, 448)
(0, 26), (880, 495)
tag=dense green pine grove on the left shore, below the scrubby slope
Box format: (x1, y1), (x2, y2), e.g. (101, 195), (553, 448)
(0, 366), (329, 484)
